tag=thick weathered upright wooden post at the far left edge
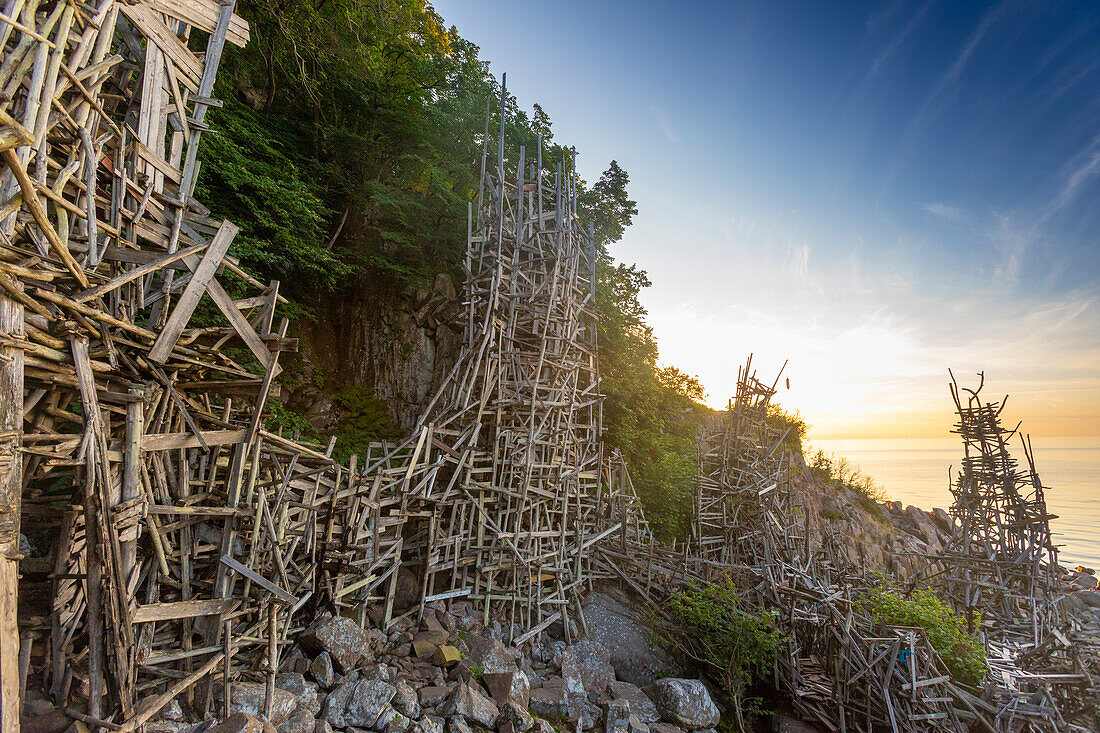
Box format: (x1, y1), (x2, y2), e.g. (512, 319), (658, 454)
(0, 278), (24, 733)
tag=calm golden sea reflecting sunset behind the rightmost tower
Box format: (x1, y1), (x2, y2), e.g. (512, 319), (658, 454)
(812, 438), (1100, 570)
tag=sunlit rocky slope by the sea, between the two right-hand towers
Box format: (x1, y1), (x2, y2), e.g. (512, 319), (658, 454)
(793, 463), (954, 578)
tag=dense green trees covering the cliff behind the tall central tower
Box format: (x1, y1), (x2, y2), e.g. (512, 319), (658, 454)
(199, 0), (705, 538)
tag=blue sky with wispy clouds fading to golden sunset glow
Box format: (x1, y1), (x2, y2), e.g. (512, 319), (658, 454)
(433, 0), (1100, 439)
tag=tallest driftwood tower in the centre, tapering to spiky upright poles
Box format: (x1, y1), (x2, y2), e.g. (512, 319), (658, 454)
(352, 78), (602, 641)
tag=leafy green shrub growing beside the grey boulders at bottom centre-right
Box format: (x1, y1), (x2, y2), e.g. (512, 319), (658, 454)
(669, 577), (785, 730)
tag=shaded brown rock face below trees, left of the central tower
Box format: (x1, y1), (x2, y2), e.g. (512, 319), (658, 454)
(288, 274), (462, 435)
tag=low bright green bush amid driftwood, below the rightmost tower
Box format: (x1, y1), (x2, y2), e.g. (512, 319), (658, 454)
(858, 582), (989, 686)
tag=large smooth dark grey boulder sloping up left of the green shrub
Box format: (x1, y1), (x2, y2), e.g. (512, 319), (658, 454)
(583, 593), (680, 687)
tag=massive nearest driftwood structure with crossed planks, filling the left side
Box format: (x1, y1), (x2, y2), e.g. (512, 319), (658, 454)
(0, 0), (365, 732)
